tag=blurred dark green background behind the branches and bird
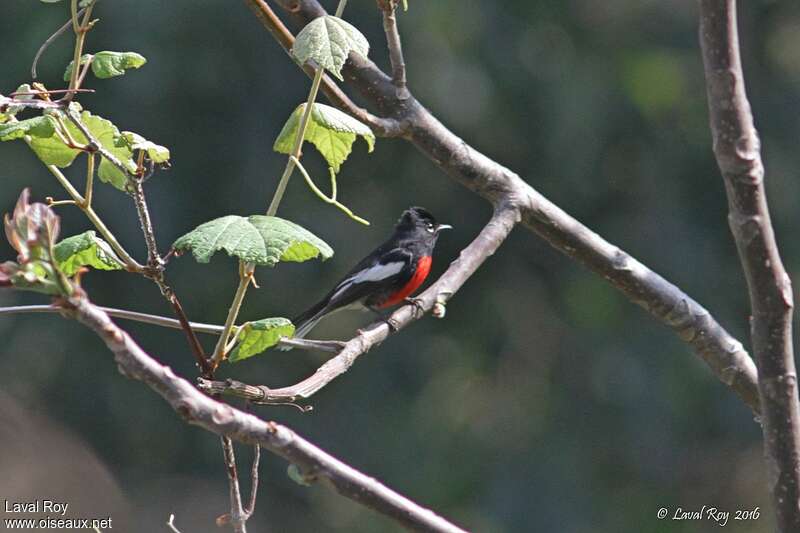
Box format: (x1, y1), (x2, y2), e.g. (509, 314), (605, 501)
(0, 0), (800, 532)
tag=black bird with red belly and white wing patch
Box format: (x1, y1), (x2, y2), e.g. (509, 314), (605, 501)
(282, 207), (452, 344)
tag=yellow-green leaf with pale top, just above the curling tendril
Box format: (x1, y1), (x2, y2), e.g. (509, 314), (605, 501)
(273, 103), (375, 176)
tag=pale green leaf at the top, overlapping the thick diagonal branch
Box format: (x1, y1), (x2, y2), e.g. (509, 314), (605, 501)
(292, 15), (369, 81)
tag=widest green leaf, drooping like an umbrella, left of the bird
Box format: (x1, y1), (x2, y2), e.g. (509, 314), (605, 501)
(172, 215), (333, 266)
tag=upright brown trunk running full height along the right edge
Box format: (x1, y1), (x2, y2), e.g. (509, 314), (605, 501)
(700, 0), (800, 532)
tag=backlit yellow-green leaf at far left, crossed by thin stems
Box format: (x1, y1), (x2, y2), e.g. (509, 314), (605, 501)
(31, 111), (136, 191)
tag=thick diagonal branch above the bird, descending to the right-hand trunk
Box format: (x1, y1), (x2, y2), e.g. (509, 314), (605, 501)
(248, 0), (760, 413)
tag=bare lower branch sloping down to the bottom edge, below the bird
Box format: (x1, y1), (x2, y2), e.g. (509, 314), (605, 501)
(63, 295), (464, 533)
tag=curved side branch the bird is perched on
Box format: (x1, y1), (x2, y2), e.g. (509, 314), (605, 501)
(199, 204), (519, 403)
